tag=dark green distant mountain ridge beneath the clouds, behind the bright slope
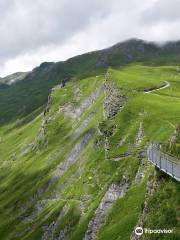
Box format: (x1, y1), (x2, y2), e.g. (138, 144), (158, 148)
(0, 39), (180, 124)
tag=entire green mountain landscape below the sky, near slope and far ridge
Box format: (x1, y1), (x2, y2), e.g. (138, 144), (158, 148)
(0, 39), (180, 240)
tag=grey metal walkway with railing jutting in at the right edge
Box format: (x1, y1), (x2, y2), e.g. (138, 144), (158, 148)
(147, 144), (180, 182)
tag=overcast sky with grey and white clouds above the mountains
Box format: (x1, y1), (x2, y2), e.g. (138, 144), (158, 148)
(0, 0), (180, 76)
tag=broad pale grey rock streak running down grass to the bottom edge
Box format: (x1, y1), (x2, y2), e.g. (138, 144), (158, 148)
(84, 177), (129, 240)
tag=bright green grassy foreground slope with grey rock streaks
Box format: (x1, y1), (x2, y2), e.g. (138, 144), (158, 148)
(0, 64), (180, 240)
